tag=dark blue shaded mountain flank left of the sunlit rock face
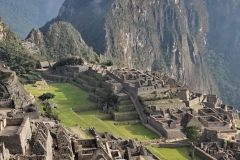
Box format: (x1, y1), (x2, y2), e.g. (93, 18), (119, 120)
(56, 0), (114, 53)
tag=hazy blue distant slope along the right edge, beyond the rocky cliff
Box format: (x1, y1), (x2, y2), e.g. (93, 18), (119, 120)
(205, 0), (240, 105)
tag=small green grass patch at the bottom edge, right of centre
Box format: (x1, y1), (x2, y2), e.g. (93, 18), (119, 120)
(147, 146), (202, 160)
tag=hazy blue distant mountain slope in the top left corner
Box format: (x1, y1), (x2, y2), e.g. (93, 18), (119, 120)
(0, 0), (64, 39)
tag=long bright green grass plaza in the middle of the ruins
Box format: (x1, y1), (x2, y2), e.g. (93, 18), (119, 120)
(25, 81), (158, 141)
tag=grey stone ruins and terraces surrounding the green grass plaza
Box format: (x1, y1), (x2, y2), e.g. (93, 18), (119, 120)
(0, 64), (240, 160)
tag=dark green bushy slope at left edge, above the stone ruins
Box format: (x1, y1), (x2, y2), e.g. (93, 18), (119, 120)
(0, 20), (37, 74)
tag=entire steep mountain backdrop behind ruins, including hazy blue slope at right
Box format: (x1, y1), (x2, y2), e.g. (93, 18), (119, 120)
(52, 0), (240, 107)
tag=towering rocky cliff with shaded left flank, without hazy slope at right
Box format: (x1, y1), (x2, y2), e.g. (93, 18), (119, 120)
(57, 0), (211, 91)
